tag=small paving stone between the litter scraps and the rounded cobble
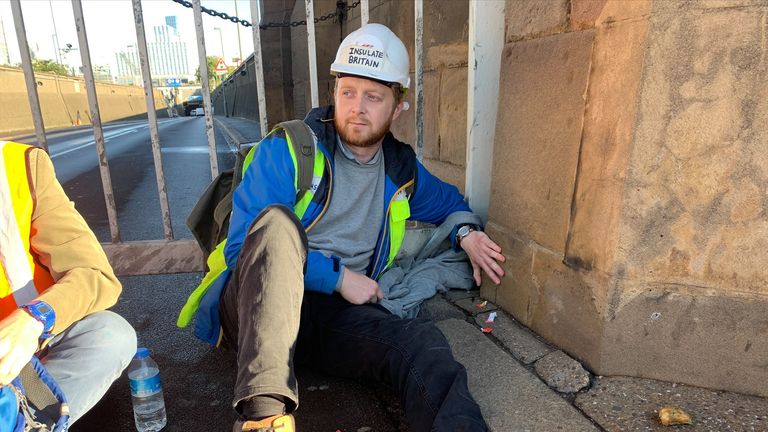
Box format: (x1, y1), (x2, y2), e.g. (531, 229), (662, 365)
(468, 310), (554, 364)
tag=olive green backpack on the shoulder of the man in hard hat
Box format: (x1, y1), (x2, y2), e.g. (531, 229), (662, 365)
(187, 120), (315, 257)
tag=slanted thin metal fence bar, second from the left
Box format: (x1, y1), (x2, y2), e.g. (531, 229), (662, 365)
(72, 0), (120, 243)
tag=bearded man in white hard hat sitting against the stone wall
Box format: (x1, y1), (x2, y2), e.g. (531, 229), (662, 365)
(190, 24), (504, 432)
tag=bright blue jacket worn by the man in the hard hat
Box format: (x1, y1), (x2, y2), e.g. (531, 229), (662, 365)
(195, 107), (471, 344)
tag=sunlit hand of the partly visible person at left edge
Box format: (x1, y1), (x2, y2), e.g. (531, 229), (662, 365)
(0, 309), (43, 386)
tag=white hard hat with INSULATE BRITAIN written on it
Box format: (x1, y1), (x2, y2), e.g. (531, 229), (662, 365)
(331, 24), (411, 89)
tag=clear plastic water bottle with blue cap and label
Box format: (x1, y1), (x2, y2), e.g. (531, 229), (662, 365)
(128, 348), (166, 432)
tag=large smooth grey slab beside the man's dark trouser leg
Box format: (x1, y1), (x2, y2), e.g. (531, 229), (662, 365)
(437, 319), (599, 432)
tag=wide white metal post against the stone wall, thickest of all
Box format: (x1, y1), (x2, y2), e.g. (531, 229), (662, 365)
(465, 1), (505, 220)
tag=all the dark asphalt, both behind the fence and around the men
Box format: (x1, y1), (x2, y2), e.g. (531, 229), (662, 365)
(16, 117), (406, 432)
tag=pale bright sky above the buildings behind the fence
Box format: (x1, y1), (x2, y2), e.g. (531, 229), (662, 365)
(0, 0), (260, 75)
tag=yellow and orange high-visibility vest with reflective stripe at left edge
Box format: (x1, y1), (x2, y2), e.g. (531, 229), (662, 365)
(0, 141), (53, 320)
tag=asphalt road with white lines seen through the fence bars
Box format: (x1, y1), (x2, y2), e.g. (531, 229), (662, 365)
(16, 117), (234, 242)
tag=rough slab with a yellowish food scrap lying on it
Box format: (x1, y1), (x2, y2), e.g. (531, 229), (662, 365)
(575, 377), (768, 432)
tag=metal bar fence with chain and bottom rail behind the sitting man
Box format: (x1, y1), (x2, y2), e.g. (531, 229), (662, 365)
(11, 0), (505, 275)
